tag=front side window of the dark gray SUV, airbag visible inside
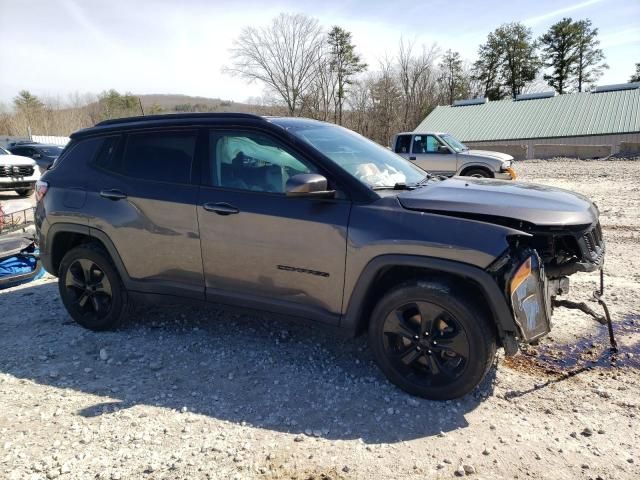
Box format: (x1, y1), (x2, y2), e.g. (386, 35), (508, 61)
(209, 132), (315, 193)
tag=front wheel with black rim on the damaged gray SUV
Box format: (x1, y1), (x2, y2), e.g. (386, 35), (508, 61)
(369, 281), (496, 400)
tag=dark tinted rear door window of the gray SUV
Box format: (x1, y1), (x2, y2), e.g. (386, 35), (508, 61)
(121, 131), (197, 183)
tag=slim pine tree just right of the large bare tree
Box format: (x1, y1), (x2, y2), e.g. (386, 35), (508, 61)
(327, 26), (367, 125)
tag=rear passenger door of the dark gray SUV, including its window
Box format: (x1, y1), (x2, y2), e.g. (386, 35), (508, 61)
(87, 128), (204, 298)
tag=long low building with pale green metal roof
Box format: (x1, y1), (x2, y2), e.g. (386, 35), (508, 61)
(415, 84), (640, 158)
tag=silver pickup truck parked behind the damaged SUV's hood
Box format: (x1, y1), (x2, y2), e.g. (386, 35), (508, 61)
(391, 132), (516, 180)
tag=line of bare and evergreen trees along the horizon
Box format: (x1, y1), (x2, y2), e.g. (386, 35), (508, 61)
(0, 13), (640, 144)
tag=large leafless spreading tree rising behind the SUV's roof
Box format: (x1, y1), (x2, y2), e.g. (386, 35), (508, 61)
(225, 13), (324, 115)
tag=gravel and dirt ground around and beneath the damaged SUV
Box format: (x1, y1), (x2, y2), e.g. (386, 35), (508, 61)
(0, 160), (640, 480)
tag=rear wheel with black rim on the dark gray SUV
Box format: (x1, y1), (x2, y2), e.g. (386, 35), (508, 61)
(58, 244), (128, 331)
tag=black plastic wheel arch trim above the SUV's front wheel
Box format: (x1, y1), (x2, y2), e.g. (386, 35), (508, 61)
(340, 255), (517, 353)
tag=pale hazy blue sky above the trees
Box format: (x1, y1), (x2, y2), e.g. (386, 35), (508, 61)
(0, 0), (640, 104)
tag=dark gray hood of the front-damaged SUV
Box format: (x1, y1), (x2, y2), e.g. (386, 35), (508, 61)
(398, 177), (598, 227)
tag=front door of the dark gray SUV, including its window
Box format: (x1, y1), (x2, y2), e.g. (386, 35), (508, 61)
(198, 129), (351, 323)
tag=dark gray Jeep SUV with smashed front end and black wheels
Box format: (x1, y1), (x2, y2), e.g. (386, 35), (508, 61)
(36, 114), (604, 399)
